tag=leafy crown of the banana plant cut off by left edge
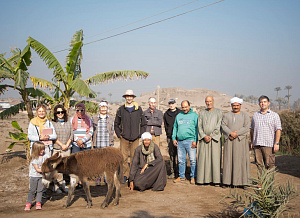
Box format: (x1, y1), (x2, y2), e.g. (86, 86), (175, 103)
(0, 45), (50, 119)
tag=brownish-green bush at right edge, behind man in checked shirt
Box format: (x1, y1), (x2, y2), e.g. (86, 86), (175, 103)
(279, 109), (300, 155)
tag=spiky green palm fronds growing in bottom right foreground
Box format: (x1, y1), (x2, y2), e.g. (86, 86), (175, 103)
(225, 168), (297, 217)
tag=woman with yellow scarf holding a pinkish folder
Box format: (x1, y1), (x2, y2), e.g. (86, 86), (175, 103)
(28, 104), (57, 156)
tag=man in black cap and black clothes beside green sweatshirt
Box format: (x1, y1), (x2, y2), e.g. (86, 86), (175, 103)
(164, 99), (181, 179)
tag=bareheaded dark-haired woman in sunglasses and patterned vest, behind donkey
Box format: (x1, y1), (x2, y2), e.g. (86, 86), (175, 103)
(52, 104), (73, 193)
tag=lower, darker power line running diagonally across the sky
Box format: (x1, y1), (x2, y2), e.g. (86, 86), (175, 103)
(53, 0), (224, 53)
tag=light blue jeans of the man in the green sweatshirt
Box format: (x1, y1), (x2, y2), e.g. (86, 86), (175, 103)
(177, 140), (197, 179)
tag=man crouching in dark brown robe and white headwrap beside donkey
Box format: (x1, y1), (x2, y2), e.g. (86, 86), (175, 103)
(129, 132), (167, 191)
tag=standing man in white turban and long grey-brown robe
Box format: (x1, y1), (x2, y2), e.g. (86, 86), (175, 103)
(222, 97), (250, 187)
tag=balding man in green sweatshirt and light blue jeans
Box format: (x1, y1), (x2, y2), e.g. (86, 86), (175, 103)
(172, 100), (198, 185)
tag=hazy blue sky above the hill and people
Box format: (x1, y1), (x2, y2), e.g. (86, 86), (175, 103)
(0, 0), (300, 101)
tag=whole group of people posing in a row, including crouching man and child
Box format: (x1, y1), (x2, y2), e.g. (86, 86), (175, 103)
(25, 90), (281, 211)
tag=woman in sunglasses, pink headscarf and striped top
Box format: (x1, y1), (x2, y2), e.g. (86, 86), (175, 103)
(71, 103), (93, 153)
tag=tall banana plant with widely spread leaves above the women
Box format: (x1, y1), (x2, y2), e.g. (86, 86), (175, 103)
(27, 30), (148, 111)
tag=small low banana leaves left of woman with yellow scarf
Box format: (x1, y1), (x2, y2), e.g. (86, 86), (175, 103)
(8, 121), (30, 160)
